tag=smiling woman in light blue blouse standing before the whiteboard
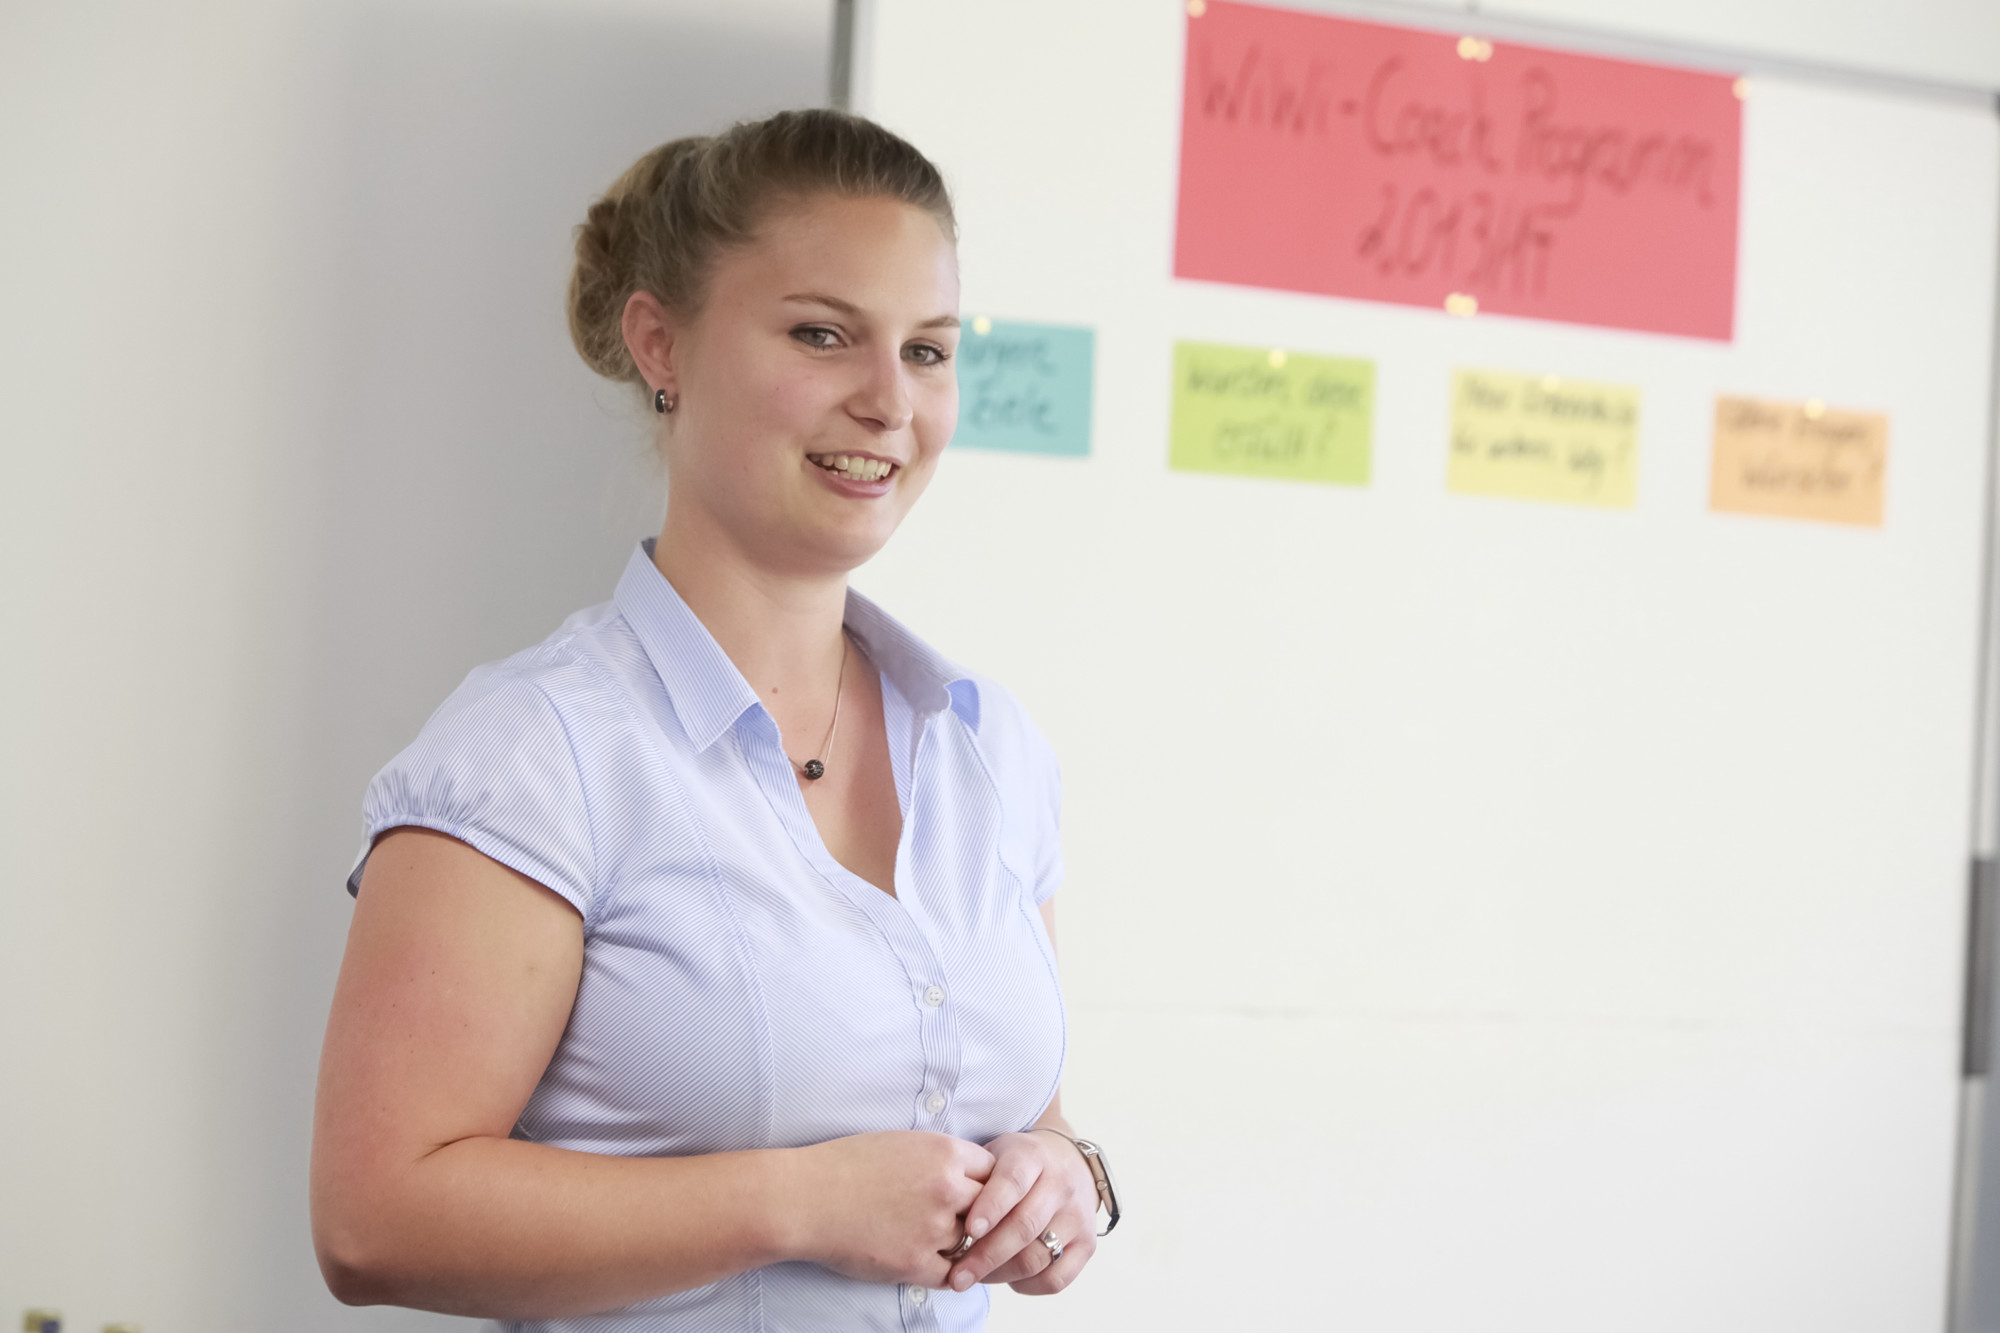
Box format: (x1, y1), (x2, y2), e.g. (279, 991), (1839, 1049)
(312, 112), (1098, 1331)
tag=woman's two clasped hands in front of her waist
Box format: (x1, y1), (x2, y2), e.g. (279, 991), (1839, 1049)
(806, 1131), (1098, 1295)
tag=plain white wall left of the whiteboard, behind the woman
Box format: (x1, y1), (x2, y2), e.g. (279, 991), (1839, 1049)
(0, 0), (832, 1333)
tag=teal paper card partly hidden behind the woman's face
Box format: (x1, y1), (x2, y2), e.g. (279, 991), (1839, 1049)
(952, 314), (1096, 458)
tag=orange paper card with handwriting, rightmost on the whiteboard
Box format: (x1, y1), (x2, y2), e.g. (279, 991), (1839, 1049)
(1708, 398), (1888, 528)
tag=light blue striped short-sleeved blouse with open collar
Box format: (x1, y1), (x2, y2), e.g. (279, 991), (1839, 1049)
(350, 542), (1064, 1333)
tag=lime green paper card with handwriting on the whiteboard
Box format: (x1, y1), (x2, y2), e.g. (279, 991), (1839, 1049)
(1168, 342), (1374, 486)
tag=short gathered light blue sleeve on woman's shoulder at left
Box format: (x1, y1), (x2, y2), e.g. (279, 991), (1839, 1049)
(348, 667), (596, 921)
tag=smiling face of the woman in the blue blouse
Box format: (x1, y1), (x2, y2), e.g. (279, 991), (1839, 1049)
(666, 196), (958, 574)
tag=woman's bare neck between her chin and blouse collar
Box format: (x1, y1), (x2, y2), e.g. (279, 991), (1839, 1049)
(652, 506), (848, 700)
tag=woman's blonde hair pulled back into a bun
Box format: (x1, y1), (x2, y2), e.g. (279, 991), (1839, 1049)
(570, 110), (958, 386)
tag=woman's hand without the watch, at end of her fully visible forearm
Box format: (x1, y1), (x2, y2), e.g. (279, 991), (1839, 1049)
(794, 1129), (992, 1287)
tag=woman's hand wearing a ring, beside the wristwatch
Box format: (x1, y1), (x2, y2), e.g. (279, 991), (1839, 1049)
(950, 1129), (1098, 1295)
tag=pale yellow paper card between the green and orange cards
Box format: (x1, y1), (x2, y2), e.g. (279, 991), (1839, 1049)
(1446, 370), (1638, 508)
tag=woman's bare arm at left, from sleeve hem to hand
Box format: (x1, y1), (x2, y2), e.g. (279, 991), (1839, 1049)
(312, 829), (992, 1319)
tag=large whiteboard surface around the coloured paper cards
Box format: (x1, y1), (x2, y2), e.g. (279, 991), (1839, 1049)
(856, 0), (2000, 1333)
